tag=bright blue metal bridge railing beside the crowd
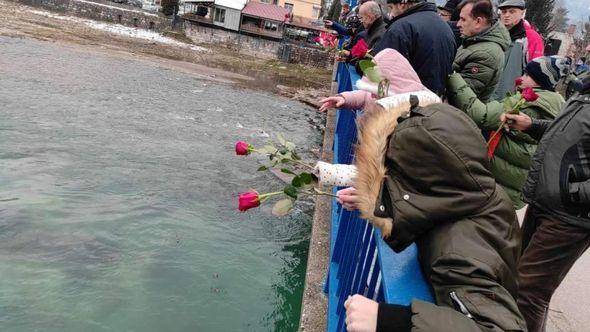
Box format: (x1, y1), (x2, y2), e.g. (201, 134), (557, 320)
(324, 63), (432, 332)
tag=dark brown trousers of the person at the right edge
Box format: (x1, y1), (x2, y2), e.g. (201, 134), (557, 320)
(518, 206), (590, 332)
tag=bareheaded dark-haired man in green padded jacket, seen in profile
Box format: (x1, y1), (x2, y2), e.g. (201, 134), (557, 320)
(453, 0), (510, 103)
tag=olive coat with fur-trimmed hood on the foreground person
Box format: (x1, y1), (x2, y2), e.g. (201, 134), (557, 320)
(355, 104), (526, 332)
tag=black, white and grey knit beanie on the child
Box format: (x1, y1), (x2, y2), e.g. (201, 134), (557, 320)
(524, 56), (569, 91)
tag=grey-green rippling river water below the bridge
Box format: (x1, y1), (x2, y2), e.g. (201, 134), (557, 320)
(0, 37), (321, 332)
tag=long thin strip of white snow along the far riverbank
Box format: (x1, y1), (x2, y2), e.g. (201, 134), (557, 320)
(29, 10), (206, 52)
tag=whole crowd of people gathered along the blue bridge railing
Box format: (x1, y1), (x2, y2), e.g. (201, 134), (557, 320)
(320, 0), (590, 332)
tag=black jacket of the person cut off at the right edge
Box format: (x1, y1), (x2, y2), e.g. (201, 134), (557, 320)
(523, 93), (590, 229)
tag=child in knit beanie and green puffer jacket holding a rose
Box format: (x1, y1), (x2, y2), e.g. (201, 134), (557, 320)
(447, 56), (568, 209)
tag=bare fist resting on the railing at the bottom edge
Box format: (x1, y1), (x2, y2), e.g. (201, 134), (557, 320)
(344, 294), (379, 332)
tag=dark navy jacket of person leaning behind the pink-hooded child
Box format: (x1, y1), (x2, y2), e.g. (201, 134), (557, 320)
(372, 2), (457, 95)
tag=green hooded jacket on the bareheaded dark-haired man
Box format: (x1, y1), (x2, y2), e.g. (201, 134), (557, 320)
(453, 21), (511, 102)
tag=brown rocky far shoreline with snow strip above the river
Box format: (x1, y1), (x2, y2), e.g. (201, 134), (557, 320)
(0, 0), (331, 107)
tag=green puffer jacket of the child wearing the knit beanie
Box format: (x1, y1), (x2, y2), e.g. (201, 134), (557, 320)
(447, 74), (565, 209)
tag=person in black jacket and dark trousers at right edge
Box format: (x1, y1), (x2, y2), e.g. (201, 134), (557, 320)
(504, 74), (590, 332)
